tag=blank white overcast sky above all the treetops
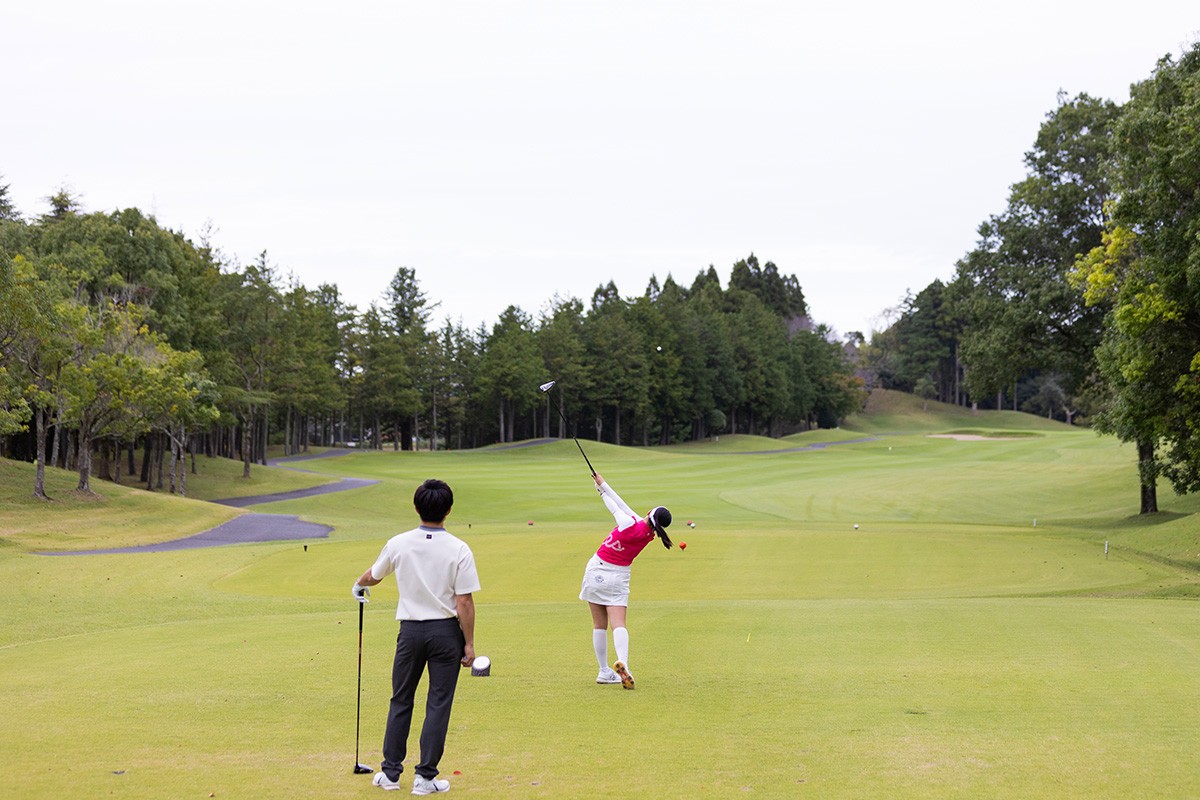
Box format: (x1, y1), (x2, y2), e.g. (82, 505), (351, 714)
(0, 0), (1200, 332)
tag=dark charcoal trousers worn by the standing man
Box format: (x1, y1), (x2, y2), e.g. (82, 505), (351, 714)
(382, 618), (466, 781)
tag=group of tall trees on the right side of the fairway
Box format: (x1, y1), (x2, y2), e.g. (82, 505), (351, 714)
(864, 44), (1200, 513)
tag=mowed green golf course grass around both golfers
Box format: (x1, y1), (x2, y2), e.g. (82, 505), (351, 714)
(0, 398), (1200, 799)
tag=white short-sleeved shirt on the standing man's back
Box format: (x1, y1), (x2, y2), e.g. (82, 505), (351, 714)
(371, 525), (480, 620)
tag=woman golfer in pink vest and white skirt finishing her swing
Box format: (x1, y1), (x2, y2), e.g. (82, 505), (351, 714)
(580, 473), (671, 688)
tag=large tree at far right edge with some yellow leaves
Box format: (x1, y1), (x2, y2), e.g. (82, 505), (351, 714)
(1078, 44), (1200, 513)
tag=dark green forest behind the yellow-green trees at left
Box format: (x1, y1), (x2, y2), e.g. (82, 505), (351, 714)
(0, 184), (862, 470)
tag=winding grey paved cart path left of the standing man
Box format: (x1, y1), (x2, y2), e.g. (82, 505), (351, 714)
(41, 450), (379, 555)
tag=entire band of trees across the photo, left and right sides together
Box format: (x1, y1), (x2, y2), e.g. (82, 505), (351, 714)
(11, 38), (1200, 512)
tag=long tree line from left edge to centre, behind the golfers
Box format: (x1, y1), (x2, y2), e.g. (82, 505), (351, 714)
(0, 186), (865, 497)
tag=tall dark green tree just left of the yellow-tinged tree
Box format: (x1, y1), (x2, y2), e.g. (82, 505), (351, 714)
(955, 94), (1120, 408)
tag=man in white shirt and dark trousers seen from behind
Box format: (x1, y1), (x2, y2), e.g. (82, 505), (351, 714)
(354, 479), (480, 794)
